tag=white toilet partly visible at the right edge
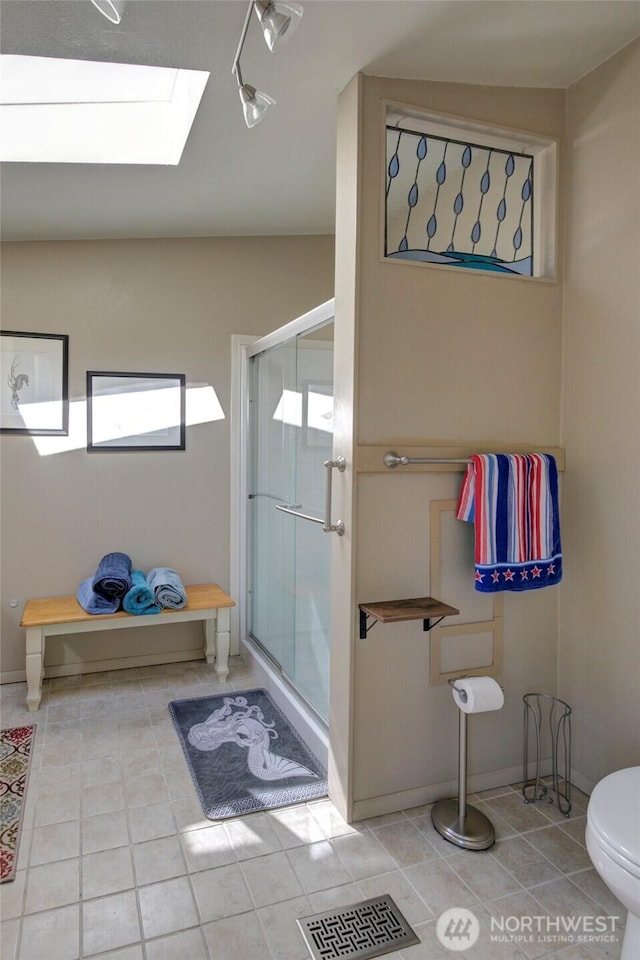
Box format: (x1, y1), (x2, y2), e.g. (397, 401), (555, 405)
(586, 767), (640, 960)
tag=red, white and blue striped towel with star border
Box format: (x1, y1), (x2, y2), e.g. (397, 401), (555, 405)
(457, 453), (562, 593)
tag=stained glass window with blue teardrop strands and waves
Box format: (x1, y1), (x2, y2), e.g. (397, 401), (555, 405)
(384, 116), (548, 277)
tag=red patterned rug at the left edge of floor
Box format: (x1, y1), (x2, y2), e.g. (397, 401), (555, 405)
(0, 724), (36, 883)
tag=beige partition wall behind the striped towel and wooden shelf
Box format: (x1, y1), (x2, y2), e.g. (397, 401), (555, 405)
(334, 77), (565, 817)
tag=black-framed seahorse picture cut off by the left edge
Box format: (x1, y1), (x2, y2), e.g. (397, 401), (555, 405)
(0, 330), (69, 436)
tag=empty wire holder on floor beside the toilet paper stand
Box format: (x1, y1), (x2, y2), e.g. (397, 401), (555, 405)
(522, 693), (571, 817)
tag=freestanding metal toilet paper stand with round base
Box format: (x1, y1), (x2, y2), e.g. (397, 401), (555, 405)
(431, 677), (496, 850)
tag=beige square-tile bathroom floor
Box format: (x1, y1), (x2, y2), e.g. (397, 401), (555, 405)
(0, 658), (624, 960)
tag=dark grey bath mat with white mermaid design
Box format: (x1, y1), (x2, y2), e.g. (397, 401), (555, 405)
(169, 689), (327, 820)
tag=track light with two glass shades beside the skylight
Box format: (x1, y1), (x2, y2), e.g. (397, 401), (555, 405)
(232, 0), (302, 127)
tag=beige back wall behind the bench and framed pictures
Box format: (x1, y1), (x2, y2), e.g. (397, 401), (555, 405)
(1, 237), (334, 679)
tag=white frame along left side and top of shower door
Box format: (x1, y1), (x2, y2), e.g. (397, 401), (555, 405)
(230, 298), (335, 690)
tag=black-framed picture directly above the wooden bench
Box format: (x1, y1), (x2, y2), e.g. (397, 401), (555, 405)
(87, 370), (186, 453)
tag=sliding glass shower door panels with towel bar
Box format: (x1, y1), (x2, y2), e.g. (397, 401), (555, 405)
(248, 322), (333, 720)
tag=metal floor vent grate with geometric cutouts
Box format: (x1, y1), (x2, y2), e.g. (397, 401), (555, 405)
(298, 894), (420, 960)
